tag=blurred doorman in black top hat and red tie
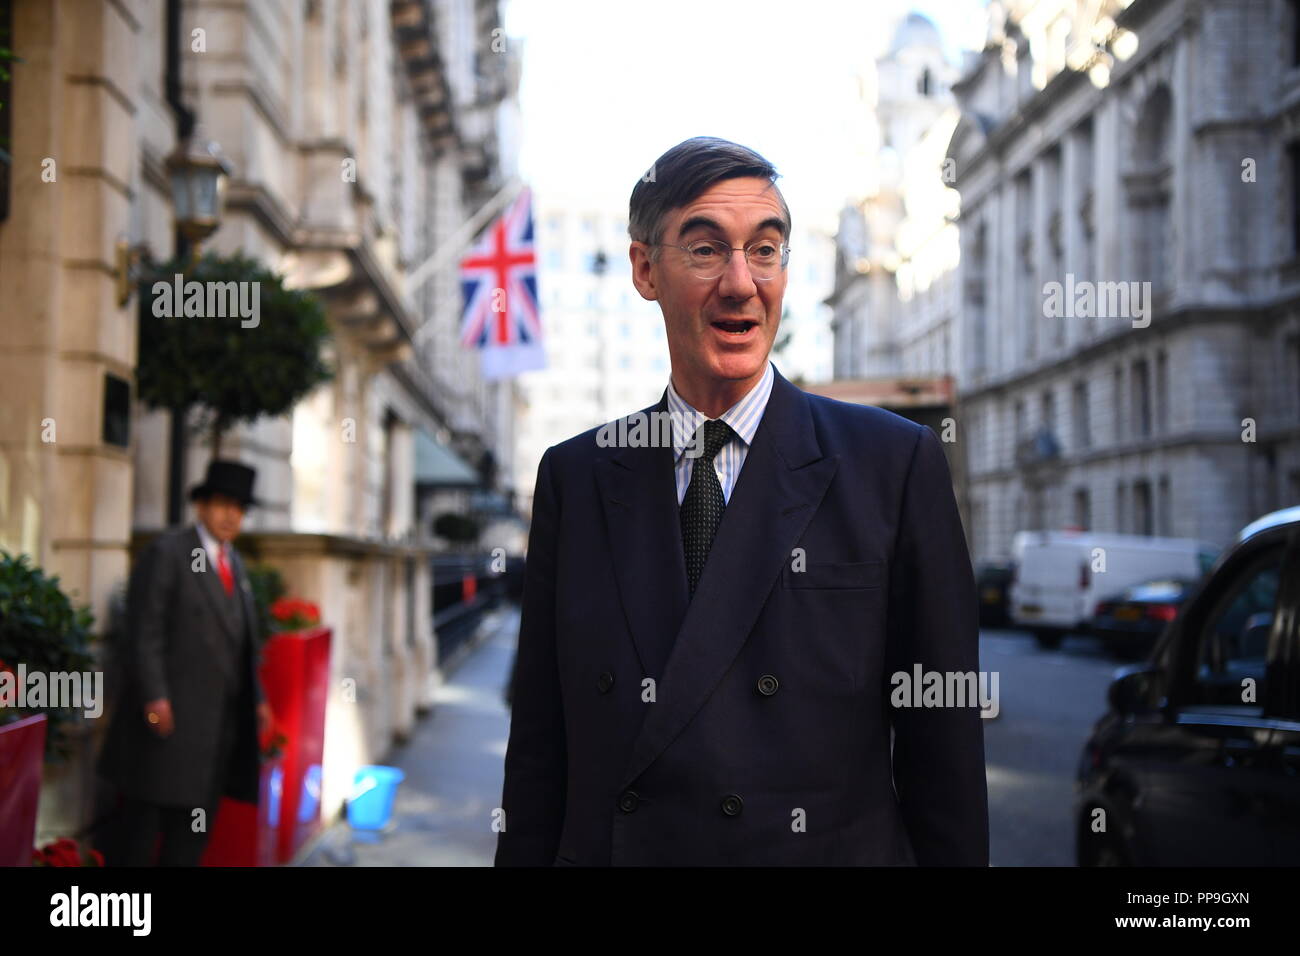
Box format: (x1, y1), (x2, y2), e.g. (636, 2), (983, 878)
(99, 460), (270, 866)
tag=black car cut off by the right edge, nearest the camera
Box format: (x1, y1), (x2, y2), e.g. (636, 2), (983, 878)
(1075, 507), (1300, 866)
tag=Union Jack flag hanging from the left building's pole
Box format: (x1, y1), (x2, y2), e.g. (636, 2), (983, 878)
(460, 186), (545, 377)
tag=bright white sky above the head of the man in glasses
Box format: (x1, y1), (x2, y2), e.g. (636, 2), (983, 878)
(504, 0), (984, 233)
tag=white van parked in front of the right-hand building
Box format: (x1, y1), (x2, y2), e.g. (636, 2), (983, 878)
(1009, 531), (1218, 648)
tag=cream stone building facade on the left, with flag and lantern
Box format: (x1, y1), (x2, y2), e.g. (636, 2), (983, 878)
(0, 0), (519, 835)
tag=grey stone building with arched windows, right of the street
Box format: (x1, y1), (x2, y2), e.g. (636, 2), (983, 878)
(949, 0), (1300, 561)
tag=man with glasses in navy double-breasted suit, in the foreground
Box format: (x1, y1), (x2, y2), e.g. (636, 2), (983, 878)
(495, 138), (988, 866)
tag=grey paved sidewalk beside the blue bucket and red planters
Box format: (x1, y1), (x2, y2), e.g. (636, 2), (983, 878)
(298, 605), (519, 866)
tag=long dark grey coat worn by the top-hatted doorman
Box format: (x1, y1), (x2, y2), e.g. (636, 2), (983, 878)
(99, 525), (263, 806)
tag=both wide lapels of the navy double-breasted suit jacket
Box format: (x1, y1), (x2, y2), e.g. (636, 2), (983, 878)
(606, 372), (839, 786)
